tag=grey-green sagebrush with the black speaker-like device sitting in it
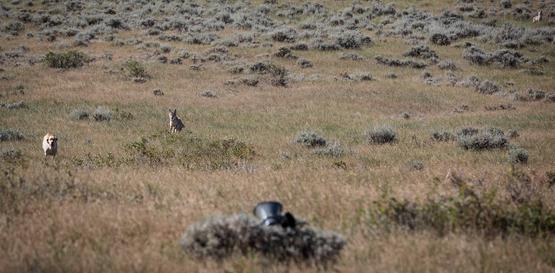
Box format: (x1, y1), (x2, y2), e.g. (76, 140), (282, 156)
(180, 214), (346, 266)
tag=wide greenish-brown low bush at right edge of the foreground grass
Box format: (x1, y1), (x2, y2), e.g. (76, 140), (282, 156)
(369, 188), (555, 236)
